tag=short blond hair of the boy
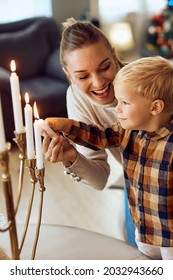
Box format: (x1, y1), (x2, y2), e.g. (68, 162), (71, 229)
(114, 56), (173, 113)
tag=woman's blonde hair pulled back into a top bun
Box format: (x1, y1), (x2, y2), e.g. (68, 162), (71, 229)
(60, 17), (123, 70)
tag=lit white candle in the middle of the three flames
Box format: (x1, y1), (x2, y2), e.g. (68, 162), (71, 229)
(24, 92), (34, 159)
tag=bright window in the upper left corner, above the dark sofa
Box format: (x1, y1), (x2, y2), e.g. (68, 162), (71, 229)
(0, 0), (52, 23)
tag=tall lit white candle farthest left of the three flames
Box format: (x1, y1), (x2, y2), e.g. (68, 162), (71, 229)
(10, 60), (23, 133)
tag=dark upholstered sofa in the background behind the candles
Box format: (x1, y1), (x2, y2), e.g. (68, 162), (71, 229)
(0, 17), (68, 140)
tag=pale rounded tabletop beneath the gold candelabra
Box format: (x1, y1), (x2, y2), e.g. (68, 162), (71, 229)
(0, 225), (148, 260)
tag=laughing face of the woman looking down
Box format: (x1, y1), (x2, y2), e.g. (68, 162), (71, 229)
(62, 41), (117, 104)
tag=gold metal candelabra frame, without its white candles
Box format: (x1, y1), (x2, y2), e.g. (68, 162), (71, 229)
(0, 131), (45, 260)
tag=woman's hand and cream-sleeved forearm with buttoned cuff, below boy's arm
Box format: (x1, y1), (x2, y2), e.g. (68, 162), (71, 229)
(43, 132), (110, 190)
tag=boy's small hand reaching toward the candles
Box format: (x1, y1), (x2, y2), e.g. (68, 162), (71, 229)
(45, 118), (72, 134)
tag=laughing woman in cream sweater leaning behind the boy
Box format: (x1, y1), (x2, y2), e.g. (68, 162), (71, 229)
(43, 18), (135, 245)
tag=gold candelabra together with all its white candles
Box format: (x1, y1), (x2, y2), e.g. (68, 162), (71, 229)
(0, 60), (47, 259)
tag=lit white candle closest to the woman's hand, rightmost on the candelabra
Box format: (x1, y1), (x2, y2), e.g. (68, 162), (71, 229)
(34, 103), (43, 169)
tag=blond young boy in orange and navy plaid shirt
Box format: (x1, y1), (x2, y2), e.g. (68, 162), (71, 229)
(47, 57), (173, 260)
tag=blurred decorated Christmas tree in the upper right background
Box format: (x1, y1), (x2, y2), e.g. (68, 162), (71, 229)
(143, 0), (173, 58)
